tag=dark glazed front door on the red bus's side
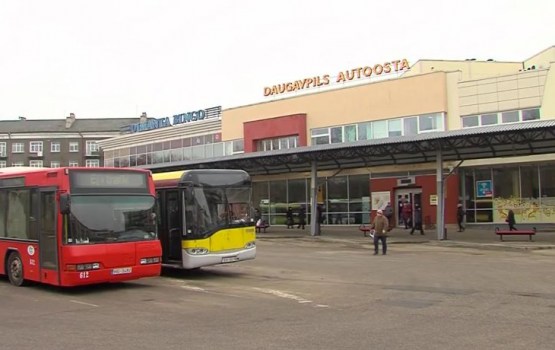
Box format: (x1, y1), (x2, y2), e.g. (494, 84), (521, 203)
(34, 188), (60, 284)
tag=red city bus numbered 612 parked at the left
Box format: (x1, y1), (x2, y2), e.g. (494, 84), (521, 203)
(0, 168), (162, 286)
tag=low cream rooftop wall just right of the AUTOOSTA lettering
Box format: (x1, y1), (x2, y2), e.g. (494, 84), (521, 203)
(403, 60), (523, 81)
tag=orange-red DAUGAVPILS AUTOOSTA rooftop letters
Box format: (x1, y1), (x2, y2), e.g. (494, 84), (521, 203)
(264, 59), (410, 96)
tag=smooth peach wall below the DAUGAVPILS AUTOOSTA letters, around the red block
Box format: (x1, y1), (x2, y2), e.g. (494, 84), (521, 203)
(222, 72), (447, 141)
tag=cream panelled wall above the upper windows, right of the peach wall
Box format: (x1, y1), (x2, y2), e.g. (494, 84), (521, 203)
(458, 69), (549, 119)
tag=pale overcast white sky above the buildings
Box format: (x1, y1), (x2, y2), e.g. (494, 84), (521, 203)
(0, 0), (555, 120)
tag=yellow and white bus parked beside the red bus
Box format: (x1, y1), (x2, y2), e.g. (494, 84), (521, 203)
(153, 169), (256, 269)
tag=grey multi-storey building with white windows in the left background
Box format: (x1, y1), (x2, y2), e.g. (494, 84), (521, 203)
(0, 113), (138, 168)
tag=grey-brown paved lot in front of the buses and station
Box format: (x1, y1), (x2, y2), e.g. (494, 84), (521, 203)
(0, 237), (555, 350)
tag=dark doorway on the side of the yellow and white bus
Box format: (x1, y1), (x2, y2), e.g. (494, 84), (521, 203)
(160, 190), (183, 261)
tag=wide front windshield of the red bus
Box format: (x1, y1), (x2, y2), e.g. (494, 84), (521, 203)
(69, 195), (157, 244)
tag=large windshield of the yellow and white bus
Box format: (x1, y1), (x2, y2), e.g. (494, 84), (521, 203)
(185, 187), (254, 238)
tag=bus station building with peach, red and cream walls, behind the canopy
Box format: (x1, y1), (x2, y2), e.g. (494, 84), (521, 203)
(100, 47), (555, 225)
